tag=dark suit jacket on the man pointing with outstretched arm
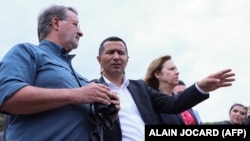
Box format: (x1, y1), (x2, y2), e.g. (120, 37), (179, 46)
(99, 77), (209, 141)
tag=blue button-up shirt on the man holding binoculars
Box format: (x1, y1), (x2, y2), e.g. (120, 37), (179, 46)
(0, 40), (89, 141)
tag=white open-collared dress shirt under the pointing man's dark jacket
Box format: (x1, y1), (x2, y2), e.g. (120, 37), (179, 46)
(103, 76), (145, 141)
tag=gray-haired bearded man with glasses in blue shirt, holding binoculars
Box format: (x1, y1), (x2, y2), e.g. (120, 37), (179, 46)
(0, 5), (120, 141)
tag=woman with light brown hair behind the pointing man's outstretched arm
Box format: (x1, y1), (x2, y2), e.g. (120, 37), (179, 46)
(144, 55), (200, 125)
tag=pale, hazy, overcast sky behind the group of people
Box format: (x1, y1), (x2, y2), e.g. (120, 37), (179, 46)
(0, 0), (250, 122)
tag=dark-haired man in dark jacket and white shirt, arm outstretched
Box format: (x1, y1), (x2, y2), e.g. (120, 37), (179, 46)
(97, 37), (235, 141)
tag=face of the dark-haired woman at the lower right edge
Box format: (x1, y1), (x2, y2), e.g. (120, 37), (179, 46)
(229, 105), (247, 124)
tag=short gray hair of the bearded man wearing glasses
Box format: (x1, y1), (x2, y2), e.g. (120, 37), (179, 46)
(37, 5), (78, 42)
